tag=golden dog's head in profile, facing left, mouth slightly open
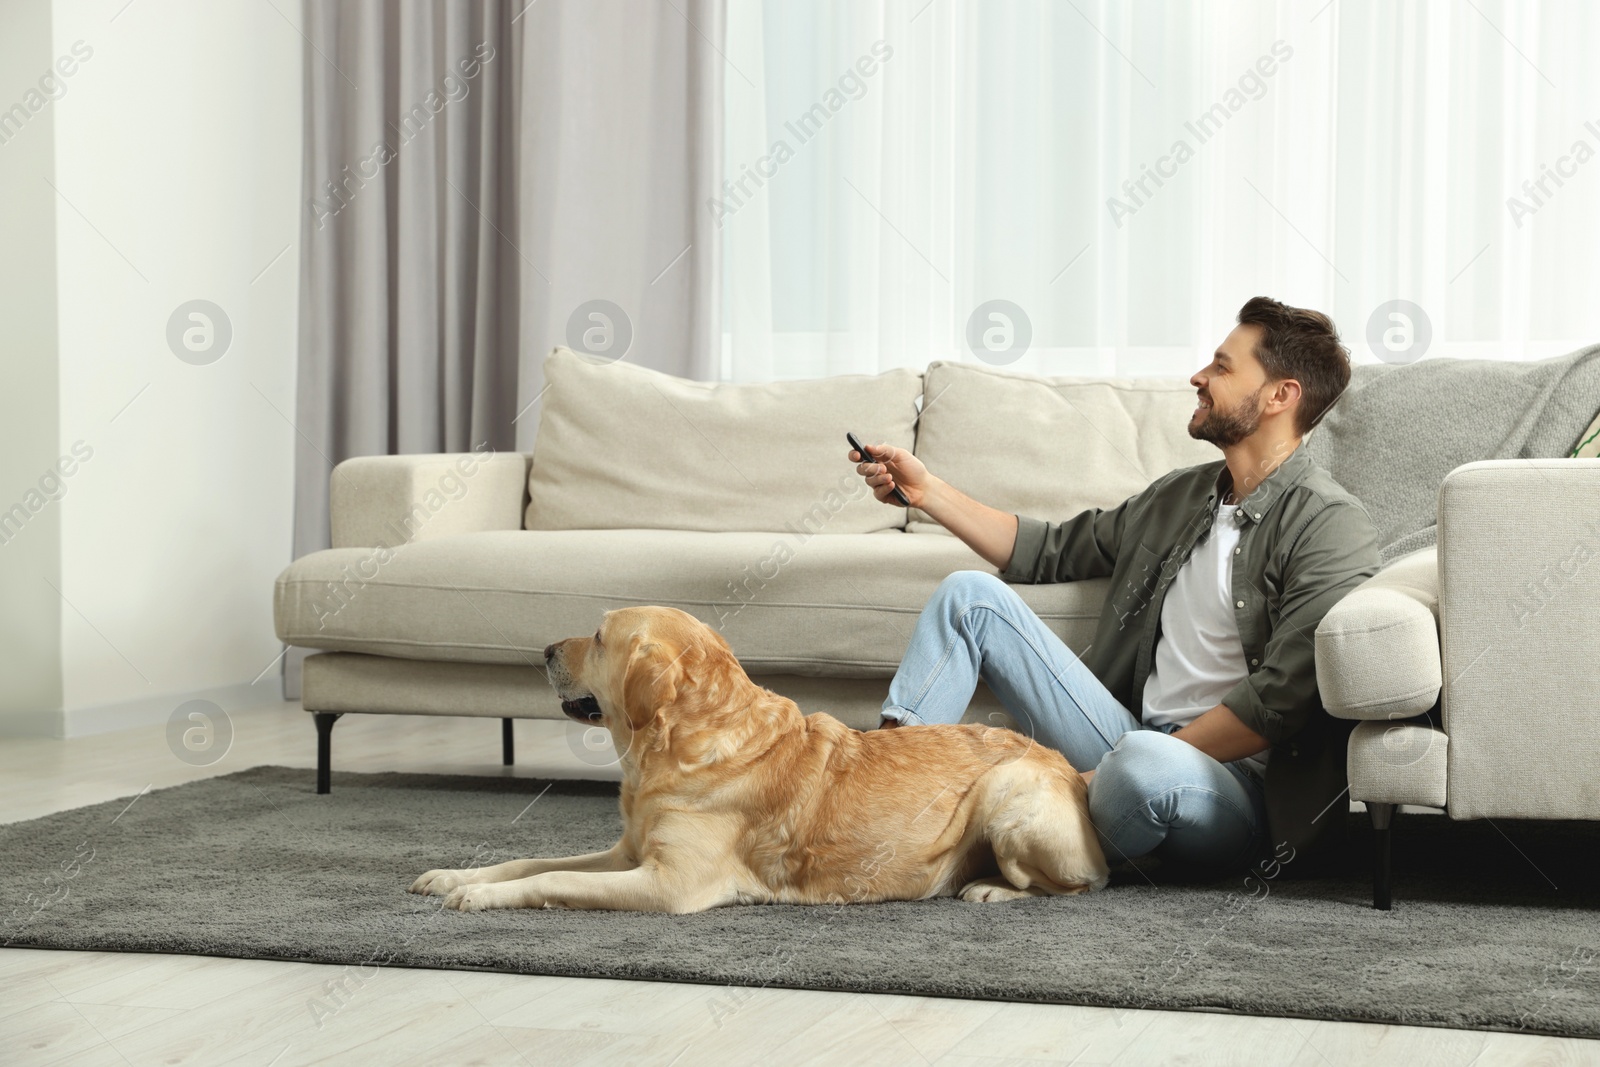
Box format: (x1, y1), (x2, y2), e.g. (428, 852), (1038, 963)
(544, 606), (754, 752)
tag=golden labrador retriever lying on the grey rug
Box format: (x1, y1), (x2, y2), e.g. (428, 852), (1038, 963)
(411, 606), (1107, 913)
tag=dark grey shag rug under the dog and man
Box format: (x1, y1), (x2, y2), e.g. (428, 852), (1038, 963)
(0, 766), (1600, 1037)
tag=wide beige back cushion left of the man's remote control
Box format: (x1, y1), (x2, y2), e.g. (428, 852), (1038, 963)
(525, 347), (922, 534)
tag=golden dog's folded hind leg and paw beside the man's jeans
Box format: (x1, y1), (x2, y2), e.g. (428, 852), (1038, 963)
(957, 761), (1109, 901)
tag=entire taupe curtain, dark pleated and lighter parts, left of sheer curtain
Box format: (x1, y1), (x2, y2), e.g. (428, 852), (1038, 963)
(294, 0), (725, 557)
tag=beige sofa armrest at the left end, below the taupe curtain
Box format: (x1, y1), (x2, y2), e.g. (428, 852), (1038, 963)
(328, 451), (528, 549)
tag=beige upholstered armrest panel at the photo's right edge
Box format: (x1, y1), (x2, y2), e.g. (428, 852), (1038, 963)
(1438, 459), (1600, 819)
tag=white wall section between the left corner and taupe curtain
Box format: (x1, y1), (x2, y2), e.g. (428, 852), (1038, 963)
(8, 0), (304, 734)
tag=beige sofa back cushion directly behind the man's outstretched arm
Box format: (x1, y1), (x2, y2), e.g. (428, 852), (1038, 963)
(907, 360), (1219, 534)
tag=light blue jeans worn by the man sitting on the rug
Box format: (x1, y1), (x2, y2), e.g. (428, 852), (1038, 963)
(883, 571), (1269, 872)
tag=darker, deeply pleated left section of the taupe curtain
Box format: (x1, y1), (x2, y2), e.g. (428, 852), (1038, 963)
(294, 0), (522, 557)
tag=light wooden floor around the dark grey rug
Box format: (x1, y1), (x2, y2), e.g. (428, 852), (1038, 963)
(0, 704), (1600, 1067)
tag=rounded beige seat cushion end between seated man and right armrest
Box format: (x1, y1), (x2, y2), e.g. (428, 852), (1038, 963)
(1317, 547), (1443, 720)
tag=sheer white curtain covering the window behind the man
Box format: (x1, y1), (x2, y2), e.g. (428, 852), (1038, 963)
(723, 0), (1600, 381)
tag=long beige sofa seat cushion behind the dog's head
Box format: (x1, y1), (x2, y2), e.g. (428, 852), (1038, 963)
(274, 530), (1107, 678)
